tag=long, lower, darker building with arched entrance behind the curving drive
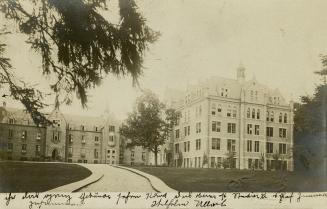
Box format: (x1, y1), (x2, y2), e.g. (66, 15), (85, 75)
(0, 103), (120, 164)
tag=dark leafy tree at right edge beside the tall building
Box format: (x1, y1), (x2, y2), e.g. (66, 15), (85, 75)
(293, 55), (327, 172)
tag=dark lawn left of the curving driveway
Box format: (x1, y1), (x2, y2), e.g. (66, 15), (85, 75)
(0, 161), (91, 192)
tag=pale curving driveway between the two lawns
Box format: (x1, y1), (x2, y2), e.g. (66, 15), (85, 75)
(78, 164), (154, 192)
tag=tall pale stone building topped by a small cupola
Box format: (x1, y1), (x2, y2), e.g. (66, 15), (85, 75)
(170, 66), (293, 171)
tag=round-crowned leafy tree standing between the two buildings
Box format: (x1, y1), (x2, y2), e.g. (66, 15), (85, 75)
(120, 91), (174, 165)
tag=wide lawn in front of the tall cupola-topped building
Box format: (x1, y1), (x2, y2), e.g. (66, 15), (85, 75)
(129, 167), (326, 192)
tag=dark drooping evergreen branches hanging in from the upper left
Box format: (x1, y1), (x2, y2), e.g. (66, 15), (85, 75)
(0, 0), (159, 123)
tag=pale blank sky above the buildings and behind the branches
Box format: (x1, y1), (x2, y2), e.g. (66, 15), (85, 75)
(1, 0), (327, 119)
